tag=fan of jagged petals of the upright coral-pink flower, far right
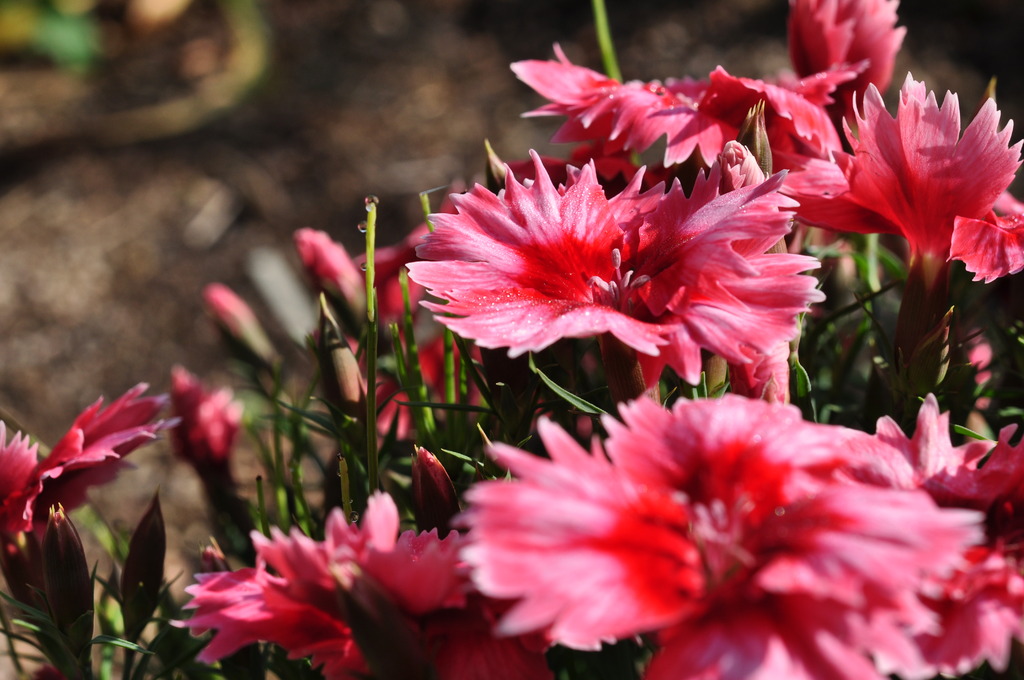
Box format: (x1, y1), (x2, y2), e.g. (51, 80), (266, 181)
(786, 75), (1021, 278)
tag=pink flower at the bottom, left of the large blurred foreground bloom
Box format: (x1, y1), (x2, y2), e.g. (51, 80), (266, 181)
(181, 494), (551, 680)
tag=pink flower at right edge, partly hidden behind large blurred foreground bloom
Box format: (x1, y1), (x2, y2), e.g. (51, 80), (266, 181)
(852, 395), (1024, 677)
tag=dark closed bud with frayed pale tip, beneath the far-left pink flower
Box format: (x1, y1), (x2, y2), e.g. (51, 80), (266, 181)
(43, 505), (92, 657)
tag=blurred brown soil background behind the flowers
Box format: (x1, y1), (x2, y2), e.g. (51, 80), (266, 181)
(0, 0), (1024, 589)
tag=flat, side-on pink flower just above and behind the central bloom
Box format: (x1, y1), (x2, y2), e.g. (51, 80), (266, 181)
(512, 45), (840, 166)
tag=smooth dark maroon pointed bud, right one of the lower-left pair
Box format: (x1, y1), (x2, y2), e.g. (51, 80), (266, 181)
(121, 494), (167, 640)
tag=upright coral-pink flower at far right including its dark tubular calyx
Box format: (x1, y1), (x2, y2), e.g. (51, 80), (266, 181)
(785, 75), (1024, 374)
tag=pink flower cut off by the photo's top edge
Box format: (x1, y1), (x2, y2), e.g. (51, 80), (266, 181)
(788, 0), (906, 123)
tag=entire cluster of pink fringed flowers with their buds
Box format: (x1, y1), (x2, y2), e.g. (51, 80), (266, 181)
(0, 0), (1024, 680)
